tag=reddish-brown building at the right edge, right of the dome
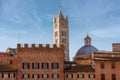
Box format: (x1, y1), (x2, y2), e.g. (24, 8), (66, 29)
(93, 52), (120, 80)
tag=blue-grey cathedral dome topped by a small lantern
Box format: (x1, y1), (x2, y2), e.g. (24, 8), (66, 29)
(75, 34), (98, 58)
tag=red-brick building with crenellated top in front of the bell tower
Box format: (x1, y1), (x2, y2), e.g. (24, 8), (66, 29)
(17, 44), (64, 80)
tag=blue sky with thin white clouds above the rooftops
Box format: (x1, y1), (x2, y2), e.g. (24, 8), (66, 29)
(0, 0), (120, 59)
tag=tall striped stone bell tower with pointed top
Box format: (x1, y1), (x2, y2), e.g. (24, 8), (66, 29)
(53, 11), (69, 61)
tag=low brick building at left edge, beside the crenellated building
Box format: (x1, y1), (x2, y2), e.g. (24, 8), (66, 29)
(0, 48), (17, 80)
